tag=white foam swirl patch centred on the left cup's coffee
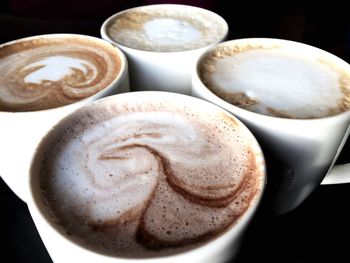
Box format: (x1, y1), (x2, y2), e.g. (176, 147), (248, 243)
(23, 56), (97, 84)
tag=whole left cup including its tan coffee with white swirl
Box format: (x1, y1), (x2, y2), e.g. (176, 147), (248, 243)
(0, 34), (129, 201)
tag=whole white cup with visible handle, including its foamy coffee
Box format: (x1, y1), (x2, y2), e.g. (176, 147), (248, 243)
(192, 38), (350, 214)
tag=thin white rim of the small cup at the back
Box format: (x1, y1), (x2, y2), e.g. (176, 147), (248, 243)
(100, 4), (229, 54)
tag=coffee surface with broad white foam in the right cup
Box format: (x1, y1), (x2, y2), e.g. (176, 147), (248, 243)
(198, 42), (350, 119)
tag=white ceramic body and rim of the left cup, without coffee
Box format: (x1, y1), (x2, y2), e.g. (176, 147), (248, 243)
(0, 34), (129, 201)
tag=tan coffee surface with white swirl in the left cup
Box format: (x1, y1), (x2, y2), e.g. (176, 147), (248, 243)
(0, 36), (121, 112)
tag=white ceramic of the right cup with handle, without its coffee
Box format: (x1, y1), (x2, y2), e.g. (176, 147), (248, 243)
(192, 38), (350, 214)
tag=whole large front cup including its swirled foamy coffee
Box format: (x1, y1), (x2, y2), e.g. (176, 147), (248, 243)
(28, 91), (265, 262)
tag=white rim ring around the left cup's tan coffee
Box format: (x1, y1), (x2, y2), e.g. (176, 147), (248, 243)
(0, 33), (128, 115)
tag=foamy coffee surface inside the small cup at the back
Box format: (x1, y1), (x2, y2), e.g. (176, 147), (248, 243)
(106, 5), (227, 52)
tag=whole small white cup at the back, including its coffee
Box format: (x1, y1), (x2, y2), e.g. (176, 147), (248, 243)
(101, 4), (228, 95)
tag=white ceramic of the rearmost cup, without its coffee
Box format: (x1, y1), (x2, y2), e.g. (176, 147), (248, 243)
(101, 4), (228, 95)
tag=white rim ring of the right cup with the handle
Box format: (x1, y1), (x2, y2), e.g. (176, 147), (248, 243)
(191, 37), (350, 123)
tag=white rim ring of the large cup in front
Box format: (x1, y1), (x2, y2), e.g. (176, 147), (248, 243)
(28, 91), (267, 262)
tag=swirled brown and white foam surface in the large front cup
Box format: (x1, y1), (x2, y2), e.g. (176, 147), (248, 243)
(38, 97), (263, 257)
